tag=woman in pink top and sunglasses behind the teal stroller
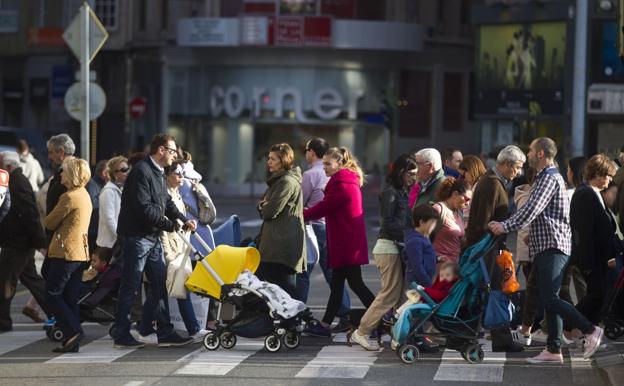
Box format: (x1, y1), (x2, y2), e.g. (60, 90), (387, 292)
(431, 177), (472, 263)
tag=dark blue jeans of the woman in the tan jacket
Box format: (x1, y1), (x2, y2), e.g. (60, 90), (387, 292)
(45, 258), (85, 339)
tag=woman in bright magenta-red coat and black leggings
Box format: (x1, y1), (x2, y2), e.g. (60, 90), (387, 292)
(303, 147), (375, 337)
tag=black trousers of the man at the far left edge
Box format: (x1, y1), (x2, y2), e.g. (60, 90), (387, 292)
(0, 247), (52, 328)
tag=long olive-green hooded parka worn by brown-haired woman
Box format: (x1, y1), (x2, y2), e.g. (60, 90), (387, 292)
(258, 167), (306, 273)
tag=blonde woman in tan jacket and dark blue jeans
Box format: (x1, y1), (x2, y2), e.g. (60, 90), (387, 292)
(44, 157), (93, 353)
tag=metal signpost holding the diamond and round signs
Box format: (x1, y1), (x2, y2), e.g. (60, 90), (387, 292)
(80, 3), (90, 162)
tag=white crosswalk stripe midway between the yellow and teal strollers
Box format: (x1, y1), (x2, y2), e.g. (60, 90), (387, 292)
(295, 345), (380, 379)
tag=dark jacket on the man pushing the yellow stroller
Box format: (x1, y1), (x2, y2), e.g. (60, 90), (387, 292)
(117, 156), (187, 240)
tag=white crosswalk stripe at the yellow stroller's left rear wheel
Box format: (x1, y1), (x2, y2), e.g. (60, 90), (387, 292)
(173, 338), (264, 375)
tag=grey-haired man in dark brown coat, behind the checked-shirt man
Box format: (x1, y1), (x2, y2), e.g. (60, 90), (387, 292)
(466, 146), (526, 352)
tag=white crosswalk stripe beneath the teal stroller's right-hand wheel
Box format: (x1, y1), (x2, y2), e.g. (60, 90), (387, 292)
(433, 340), (507, 383)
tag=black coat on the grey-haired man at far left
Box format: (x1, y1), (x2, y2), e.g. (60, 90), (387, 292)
(0, 168), (47, 249)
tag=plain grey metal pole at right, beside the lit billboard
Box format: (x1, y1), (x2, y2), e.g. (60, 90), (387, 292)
(571, 0), (589, 156)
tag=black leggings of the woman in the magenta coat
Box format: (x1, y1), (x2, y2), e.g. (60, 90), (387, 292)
(323, 265), (375, 324)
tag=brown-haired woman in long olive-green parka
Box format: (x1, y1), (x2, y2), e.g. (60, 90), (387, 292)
(256, 143), (306, 298)
